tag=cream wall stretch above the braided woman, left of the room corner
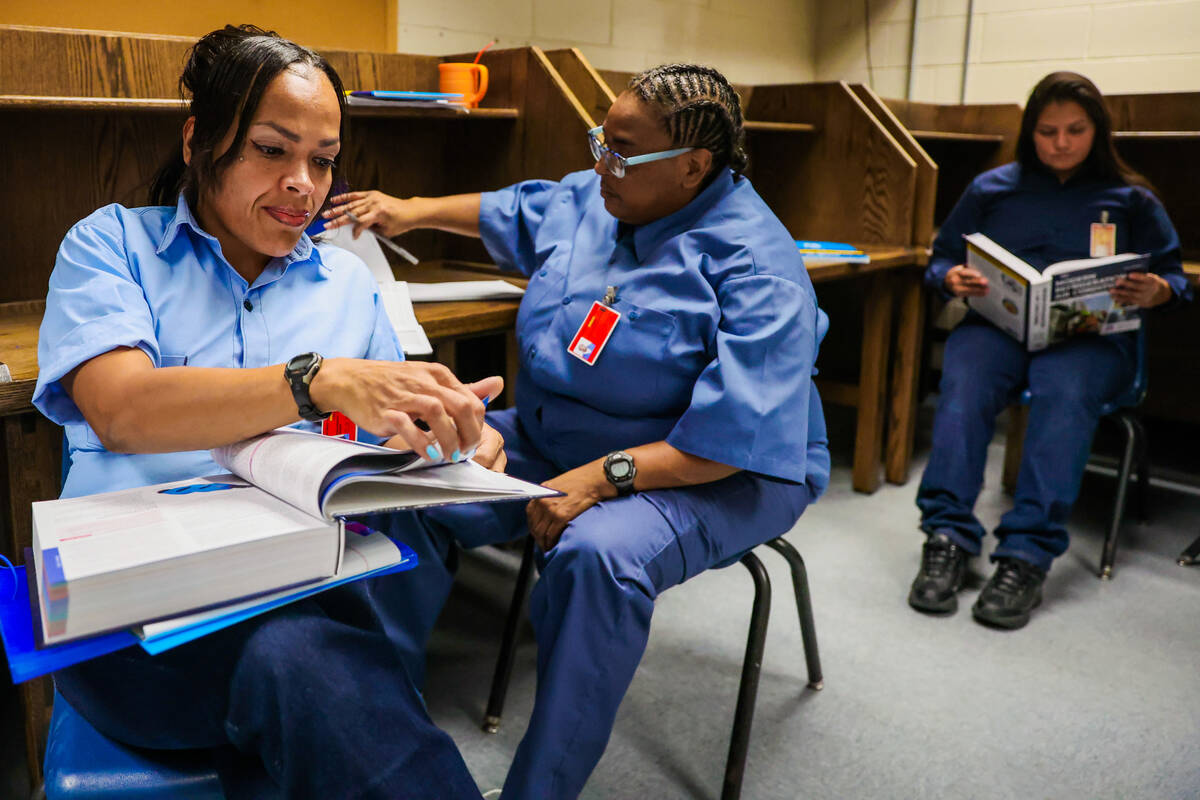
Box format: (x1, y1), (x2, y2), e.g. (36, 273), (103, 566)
(396, 0), (817, 83)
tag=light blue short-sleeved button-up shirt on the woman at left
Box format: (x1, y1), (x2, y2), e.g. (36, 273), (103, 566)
(34, 197), (403, 497)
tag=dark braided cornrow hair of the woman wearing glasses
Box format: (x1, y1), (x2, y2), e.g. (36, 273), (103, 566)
(628, 64), (749, 180)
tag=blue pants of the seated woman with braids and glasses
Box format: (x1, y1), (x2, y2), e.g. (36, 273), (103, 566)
(379, 409), (817, 800)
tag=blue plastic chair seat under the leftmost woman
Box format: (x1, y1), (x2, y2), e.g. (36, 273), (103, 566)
(35, 438), (224, 800)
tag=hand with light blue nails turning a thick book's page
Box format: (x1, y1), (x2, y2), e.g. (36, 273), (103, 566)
(310, 359), (504, 461)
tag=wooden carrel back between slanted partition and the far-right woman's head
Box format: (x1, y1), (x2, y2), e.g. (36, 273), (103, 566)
(883, 100), (1021, 227)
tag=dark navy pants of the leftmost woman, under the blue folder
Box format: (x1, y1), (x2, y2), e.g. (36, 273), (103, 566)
(54, 578), (479, 800)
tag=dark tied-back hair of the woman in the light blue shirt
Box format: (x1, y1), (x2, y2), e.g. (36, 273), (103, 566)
(150, 25), (346, 209)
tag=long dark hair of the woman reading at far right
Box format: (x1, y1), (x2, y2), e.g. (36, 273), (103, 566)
(1016, 72), (1154, 192)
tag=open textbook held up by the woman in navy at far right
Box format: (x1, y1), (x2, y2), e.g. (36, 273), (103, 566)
(965, 234), (1150, 353)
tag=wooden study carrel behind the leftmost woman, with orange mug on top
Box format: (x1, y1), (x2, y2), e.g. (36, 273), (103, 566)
(0, 26), (594, 778)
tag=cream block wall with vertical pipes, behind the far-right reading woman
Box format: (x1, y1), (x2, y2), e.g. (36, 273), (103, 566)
(815, 0), (1200, 103)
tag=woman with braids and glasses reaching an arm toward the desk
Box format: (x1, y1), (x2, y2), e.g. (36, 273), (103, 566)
(328, 65), (829, 798)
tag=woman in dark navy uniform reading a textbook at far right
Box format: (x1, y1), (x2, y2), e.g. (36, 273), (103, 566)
(908, 72), (1189, 628)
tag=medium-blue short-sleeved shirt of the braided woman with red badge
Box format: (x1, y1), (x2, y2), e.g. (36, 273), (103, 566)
(479, 170), (829, 491)
